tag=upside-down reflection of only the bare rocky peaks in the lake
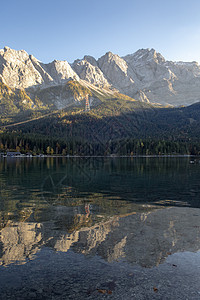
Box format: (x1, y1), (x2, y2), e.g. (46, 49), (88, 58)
(0, 208), (200, 267)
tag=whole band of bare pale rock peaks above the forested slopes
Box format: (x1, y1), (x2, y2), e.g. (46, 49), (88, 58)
(0, 47), (200, 106)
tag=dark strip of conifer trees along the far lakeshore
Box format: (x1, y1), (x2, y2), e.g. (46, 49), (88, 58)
(0, 133), (200, 156)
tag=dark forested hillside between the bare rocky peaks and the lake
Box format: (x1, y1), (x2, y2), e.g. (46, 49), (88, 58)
(0, 98), (200, 155)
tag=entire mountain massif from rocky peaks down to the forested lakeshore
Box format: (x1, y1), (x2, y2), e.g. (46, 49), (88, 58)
(0, 47), (200, 155)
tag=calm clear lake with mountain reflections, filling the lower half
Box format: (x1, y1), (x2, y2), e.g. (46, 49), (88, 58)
(0, 157), (200, 299)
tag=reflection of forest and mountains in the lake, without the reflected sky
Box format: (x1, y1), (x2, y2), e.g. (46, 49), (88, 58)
(0, 158), (200, 268)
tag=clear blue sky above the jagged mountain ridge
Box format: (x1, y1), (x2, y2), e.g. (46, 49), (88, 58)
(0, 0), (200, 62)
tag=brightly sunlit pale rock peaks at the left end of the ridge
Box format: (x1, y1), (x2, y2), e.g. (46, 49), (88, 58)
(0, 47), (79, 88)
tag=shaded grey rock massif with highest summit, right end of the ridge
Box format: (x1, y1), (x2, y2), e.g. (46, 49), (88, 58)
(123, 49), (200, 105)
